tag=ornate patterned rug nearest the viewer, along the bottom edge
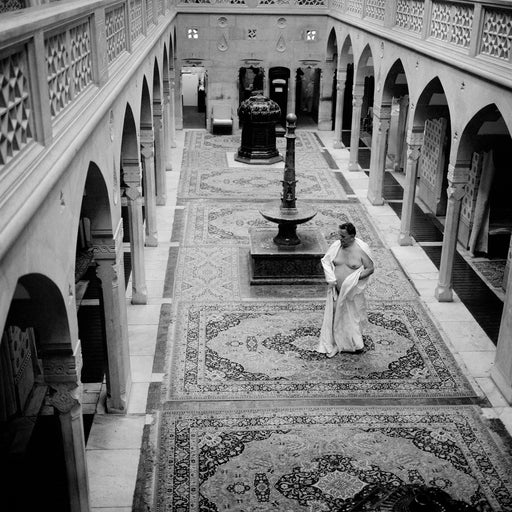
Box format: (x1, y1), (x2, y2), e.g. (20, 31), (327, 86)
(156, 406), (512, 512)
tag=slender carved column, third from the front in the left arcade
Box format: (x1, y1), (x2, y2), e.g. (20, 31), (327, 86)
(123, 157), (148, 304)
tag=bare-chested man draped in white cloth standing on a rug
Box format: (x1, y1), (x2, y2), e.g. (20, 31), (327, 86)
(316, 222), (374, 357)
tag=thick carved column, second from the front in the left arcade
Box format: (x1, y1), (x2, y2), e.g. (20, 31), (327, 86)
(92, 223), (131, 414)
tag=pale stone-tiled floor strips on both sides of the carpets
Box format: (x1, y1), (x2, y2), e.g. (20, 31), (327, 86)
(87, 131), (512, 512)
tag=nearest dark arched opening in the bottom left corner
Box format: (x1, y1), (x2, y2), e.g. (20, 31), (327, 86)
(0, 274), (86, 512)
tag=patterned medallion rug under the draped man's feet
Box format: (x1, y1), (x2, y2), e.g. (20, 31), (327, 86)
(166, 300), (475, 400)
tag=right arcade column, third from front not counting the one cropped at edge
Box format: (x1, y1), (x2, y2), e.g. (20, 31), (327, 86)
(368, 103), (391, 206)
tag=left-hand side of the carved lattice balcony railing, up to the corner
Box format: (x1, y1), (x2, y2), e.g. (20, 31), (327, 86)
(0, 0), (172, 170)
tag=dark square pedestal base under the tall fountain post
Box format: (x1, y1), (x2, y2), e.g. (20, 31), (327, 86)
(249, 228), (327, 285)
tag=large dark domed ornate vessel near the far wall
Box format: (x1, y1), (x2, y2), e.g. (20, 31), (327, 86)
(235, 94), (283, 164)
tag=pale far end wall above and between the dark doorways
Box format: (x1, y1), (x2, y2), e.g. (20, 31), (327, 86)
(176, 14), (328, 129)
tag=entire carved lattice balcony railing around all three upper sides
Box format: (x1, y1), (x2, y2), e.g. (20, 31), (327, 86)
(0, 0), (512, 171)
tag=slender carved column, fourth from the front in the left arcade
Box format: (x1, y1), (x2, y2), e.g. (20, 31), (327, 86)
(140, 128), (158, 247)
